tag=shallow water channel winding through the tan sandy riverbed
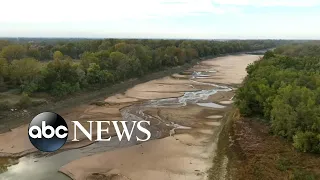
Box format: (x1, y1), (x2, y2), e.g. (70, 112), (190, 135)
(0, 72), (232, 180)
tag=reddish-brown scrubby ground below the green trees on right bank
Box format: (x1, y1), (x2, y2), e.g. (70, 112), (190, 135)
(230, 118), (320, 180)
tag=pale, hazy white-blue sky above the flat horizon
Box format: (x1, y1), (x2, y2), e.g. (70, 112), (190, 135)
(0, 0), (320, 39)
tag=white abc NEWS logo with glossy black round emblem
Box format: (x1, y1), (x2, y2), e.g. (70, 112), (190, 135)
(28, 112), (151, 152)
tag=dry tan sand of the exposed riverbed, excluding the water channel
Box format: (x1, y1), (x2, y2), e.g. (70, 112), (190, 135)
(0, 55), (259, 180)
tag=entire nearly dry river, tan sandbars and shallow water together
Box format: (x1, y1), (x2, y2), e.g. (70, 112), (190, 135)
(0, 55), (259, 180)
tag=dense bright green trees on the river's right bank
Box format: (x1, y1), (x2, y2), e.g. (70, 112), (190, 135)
(236, 43), (320, 153)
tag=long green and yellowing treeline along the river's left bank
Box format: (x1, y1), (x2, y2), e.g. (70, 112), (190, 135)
(0, 39), (281, 96)
